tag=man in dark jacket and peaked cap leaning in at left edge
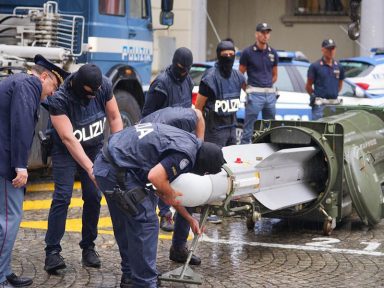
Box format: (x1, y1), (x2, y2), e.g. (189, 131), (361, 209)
(0, 55), (68, 287)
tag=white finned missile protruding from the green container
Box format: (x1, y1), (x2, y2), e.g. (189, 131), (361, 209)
(171, 143), (318, 210)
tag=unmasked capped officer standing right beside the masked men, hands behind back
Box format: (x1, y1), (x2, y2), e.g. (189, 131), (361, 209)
(239, 23), (279, 144)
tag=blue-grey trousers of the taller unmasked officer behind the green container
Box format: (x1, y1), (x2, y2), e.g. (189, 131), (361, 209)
(241, 93), (276, 144)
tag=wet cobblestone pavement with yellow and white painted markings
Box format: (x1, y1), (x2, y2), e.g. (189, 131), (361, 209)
(13, 192), (384, 288)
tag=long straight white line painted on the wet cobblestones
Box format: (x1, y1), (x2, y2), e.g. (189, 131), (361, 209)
(201, 234), (384, 256)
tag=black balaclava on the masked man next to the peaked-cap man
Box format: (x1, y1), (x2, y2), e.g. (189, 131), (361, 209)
(72, 64), (103, 106)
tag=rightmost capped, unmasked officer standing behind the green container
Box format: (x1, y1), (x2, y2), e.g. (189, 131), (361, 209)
(305, 39), (345, 120)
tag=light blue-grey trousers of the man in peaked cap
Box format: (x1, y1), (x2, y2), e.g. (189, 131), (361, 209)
(0, 176), (24, 283)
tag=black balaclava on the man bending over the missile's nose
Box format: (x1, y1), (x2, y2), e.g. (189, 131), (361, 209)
(191, 142), (226, 175)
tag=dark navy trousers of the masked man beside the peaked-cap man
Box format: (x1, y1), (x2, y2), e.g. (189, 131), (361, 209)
(45, 147), (101, 254)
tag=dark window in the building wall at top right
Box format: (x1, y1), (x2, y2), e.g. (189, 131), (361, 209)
(282, 0), (351, 26)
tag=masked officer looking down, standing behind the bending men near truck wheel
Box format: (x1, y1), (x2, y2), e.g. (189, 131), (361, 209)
(142, 47), (193, 232)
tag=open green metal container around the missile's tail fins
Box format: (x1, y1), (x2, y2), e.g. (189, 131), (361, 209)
(253, 106), (384, 235)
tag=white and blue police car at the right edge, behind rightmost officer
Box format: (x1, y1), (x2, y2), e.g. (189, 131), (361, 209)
(340, 48), (384, 97)
